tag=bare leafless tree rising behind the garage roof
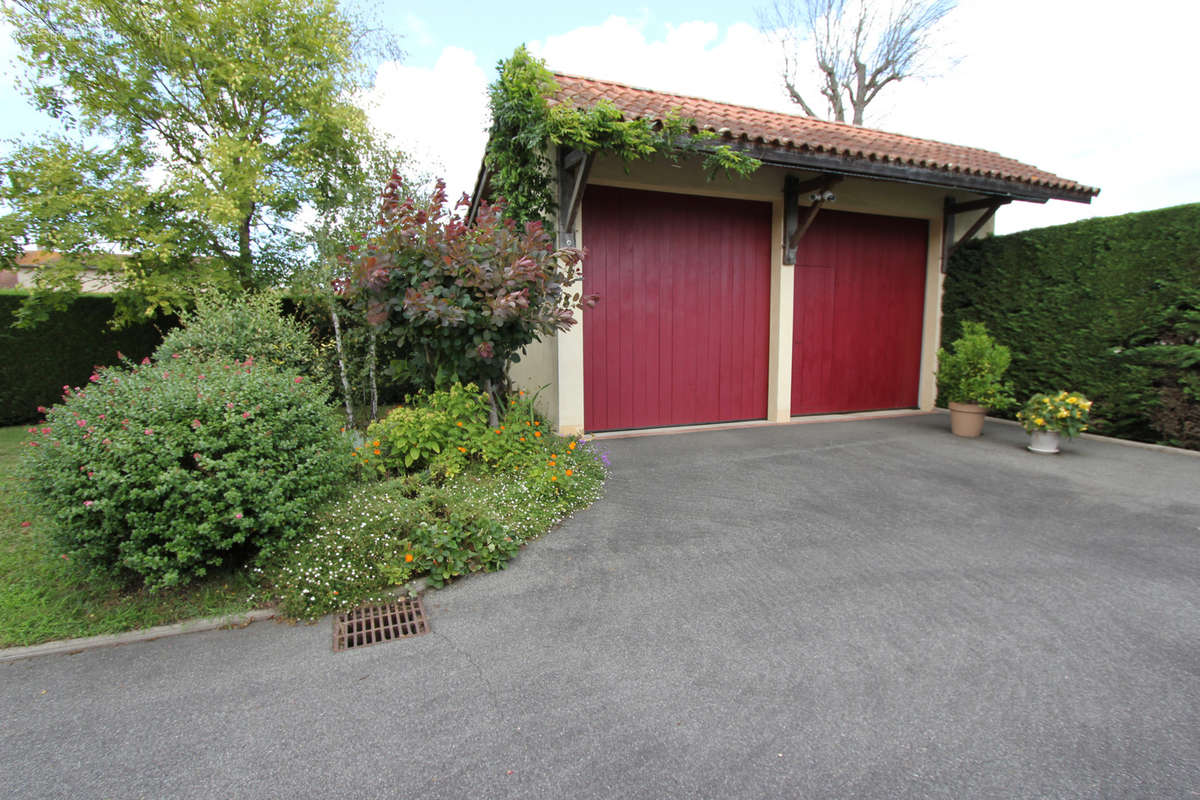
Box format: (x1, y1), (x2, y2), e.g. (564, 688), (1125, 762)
(758, 0), (956, 125)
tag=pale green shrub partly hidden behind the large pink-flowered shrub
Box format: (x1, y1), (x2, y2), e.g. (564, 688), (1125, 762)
(154, 291), (328, 381)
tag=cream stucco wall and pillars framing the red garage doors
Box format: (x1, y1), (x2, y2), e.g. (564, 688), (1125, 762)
(510, 152), (1008, 434)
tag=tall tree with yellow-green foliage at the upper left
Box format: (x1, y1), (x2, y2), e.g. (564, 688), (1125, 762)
(0, 0), (379, 323)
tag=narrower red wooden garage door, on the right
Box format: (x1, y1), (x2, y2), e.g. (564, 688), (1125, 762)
(792, 211), (929, 414)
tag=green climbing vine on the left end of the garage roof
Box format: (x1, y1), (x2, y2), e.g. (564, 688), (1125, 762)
(485, 46), (762, 222)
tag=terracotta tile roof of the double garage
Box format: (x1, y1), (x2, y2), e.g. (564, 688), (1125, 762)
(551, 73), (1099, 201)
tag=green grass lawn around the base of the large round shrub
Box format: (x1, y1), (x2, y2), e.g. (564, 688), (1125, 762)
(0, 427), (264, 646)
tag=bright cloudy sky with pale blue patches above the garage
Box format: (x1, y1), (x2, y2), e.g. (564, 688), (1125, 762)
(0, 0), (1200, 233)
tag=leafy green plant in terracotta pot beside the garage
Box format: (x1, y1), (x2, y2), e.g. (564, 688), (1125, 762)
(937, 321), (1014, 437)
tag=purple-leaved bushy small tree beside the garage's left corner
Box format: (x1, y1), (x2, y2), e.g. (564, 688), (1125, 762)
(348, 174), (596, 414)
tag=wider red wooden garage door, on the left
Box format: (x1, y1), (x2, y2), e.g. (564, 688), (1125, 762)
(583, 186), (772, 431)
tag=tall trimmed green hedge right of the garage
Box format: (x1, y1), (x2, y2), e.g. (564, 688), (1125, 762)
(942, 204), (1200, 447)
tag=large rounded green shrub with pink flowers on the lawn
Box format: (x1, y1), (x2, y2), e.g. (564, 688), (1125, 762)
(29, 357), (350, 588)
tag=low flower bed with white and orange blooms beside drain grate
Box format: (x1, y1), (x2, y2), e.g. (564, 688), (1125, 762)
(272, 386), (608, 619)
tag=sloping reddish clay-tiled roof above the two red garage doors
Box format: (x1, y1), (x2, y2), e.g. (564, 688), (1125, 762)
(551, 73), (1099, 203)
